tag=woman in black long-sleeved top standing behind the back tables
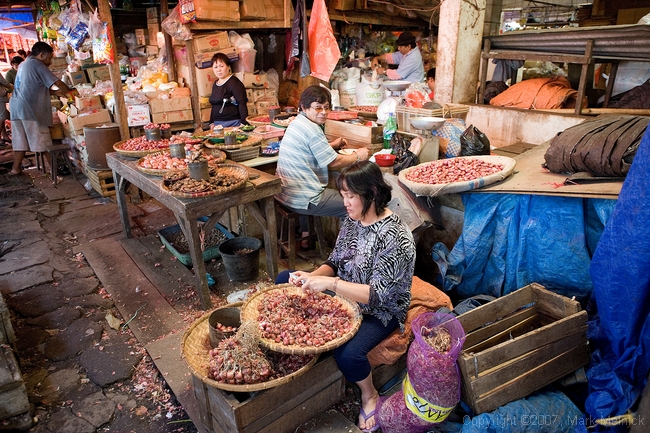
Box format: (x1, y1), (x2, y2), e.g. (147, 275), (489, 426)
(210, 53), (248, 127)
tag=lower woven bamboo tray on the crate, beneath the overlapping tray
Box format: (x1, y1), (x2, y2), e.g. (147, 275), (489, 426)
(181, 305), (318, 392)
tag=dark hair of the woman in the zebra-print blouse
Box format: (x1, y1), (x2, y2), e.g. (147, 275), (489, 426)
(336, 161), (393, 216)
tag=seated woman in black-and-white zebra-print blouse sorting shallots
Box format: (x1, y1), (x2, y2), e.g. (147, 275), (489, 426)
(276, 161), (415, 432)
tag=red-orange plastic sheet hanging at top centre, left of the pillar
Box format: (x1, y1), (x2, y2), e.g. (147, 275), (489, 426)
(309, 0), (341, 81)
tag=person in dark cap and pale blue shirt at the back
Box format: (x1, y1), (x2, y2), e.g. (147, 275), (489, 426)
(370, 32), (424, 83)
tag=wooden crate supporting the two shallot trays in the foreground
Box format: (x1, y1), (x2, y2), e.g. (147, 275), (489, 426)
(192, 355), (345, 433)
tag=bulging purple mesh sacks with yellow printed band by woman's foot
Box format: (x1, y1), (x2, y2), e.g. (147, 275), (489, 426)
(377, 311), (465, 433)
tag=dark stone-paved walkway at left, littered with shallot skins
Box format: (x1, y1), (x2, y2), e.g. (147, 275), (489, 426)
(0, 168), (359, 433)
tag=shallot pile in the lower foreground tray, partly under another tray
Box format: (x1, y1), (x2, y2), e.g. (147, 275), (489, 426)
(208, 322), (313, 385)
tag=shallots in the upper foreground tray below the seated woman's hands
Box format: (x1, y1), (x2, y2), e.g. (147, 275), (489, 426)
(257, 290), (352, 347)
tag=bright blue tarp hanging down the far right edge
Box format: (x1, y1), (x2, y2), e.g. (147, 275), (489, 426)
(585, 123), (650, 419)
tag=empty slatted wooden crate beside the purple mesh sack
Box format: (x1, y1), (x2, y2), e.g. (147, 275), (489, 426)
(458, 283), (590, 414)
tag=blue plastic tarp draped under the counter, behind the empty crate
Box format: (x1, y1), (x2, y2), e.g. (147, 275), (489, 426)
(432, 193), (616, 301)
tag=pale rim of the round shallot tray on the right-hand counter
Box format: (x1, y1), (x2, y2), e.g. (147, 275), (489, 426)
(397, 155), (517, 197)
